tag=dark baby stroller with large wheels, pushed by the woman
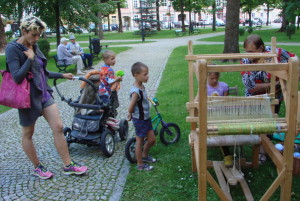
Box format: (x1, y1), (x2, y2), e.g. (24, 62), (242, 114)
(54, 75), (128, 157)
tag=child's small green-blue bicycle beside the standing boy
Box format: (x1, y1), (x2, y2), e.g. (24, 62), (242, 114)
(125, 98), (180, 163)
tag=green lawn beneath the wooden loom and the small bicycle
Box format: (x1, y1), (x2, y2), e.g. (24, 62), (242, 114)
(121, 45), (300, 201)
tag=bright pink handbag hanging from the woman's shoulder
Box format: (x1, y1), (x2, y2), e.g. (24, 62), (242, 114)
(0, 70), (32, 109)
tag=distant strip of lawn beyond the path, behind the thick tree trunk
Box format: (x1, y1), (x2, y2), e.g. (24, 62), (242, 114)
(199, 29), (300, 43)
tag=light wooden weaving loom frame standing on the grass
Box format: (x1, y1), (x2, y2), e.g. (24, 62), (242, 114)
(186, 37), (300, 201)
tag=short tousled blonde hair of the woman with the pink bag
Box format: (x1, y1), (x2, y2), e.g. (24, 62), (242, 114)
(20, 16), (47, 33)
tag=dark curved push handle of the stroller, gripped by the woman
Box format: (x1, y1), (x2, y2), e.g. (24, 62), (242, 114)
(53, 76), (101, 110)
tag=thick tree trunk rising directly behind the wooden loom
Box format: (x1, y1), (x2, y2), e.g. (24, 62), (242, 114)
(223, 0), (240, 53)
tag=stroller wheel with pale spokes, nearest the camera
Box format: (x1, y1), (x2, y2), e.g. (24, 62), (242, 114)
(100, 129), (115, 157)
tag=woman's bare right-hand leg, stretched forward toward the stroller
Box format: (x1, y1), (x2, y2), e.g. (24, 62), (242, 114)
(43, 104), (71, 166)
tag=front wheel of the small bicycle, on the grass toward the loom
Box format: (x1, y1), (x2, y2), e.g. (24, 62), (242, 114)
(159, 122), (180, 145)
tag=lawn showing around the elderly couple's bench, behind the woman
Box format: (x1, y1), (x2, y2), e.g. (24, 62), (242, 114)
(0, 47), (130, 114)
